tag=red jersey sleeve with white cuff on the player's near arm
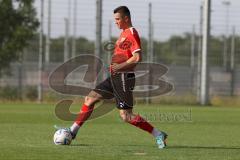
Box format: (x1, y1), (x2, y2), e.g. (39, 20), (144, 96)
(129, 30), (141, 54)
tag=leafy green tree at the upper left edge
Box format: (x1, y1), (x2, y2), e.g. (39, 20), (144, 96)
(0, 0), (39, 71)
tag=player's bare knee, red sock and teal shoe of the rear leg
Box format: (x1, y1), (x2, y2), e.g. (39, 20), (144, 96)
(119, 109), (167, 148)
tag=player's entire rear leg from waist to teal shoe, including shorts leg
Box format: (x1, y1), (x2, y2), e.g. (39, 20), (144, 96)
(112, 73), (167, 148)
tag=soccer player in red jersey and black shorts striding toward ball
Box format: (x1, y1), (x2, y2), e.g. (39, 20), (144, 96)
(56, 6), (167, 148)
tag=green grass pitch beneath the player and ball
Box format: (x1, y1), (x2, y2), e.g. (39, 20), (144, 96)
(0, 104), (240, 160)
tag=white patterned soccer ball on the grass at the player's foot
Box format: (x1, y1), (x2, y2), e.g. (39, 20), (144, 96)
(53, 129), (72, 145)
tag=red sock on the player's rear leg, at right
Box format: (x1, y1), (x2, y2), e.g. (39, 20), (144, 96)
(129, 115), (154, 134)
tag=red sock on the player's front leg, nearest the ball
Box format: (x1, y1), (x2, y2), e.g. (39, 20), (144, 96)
(75, 104), (94, 126)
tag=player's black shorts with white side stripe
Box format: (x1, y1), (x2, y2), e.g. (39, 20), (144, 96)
(94, 73), (135, 109)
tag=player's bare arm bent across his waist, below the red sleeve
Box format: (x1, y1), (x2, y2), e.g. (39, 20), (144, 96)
(111, 51), (142, 74)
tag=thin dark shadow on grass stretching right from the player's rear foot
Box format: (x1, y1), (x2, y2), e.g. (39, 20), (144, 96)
(167, 146), (240, 150)
